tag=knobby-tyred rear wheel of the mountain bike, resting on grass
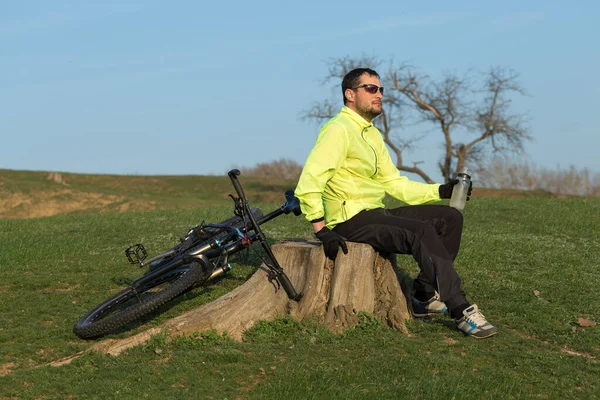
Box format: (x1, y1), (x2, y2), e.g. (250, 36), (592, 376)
(73, 261), (208, 339)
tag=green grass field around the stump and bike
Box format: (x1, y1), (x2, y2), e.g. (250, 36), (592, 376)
(0, 198), (600, 399)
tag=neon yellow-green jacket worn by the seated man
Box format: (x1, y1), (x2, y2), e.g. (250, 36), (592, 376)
(295, 107), (440, 229)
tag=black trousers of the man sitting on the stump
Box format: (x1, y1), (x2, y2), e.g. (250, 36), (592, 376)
(333, 205), (469, 310)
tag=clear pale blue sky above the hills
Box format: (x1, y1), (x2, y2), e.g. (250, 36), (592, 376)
(0, 0), (600, 180)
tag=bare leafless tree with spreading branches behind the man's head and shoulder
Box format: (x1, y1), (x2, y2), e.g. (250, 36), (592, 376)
(302, 56), (530, 183)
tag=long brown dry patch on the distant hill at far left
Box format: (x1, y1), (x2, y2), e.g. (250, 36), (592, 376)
(0, 189), (156, 219)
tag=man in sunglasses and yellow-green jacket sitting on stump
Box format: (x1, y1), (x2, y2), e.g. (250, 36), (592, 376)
(295, 68), (498, 338)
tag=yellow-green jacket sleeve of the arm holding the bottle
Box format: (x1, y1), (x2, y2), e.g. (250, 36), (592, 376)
(375, 134), (440, 205)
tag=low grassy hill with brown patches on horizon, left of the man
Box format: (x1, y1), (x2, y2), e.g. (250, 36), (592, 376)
(0, 170), (295, 218)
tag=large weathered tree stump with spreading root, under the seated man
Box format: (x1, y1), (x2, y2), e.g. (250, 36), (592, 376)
(63, 239), (411, 360)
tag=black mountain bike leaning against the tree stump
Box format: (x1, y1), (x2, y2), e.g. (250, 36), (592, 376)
(73, 169), (302, 339)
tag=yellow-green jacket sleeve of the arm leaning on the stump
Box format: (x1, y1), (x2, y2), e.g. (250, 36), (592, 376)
(295, 123), (348, 221)
